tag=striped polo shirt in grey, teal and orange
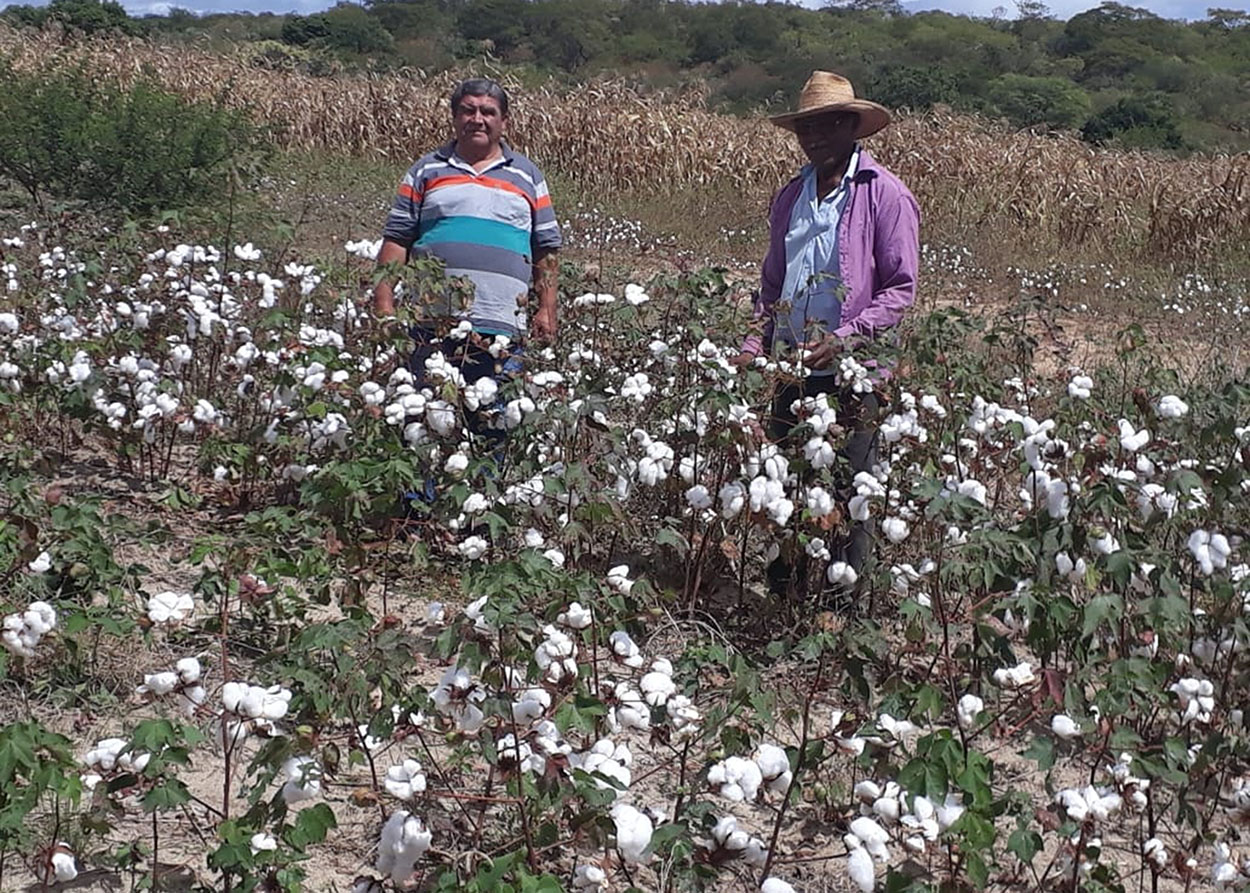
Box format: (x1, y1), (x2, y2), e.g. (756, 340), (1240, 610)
(383, 141), (561, 335)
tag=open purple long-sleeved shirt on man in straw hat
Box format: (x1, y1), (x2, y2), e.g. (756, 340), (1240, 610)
(743, 149), (920, 355)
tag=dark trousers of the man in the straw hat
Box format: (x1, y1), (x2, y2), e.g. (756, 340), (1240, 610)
(768, 376), (883, 594)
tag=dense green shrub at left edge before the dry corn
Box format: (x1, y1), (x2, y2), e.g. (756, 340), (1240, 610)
(0, 66), (261, 213)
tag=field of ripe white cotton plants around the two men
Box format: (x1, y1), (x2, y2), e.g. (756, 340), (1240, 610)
(0, 217), (1250, 893)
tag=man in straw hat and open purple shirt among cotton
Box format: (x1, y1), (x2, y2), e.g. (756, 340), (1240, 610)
(736, 71), (920, 592)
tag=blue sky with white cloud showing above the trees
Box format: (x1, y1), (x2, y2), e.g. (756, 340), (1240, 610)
(0, 0), (1250, 19)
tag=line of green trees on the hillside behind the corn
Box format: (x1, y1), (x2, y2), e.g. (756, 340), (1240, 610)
(0, 0), (1250, 151)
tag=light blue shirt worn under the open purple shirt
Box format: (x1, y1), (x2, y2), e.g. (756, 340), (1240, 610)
(776, 146), (859, 346)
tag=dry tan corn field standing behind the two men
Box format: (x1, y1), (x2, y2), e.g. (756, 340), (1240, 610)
(7, 28), (1250, 263)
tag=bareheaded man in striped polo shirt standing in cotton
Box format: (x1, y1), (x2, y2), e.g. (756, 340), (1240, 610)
(374, 79), (561, 355)
